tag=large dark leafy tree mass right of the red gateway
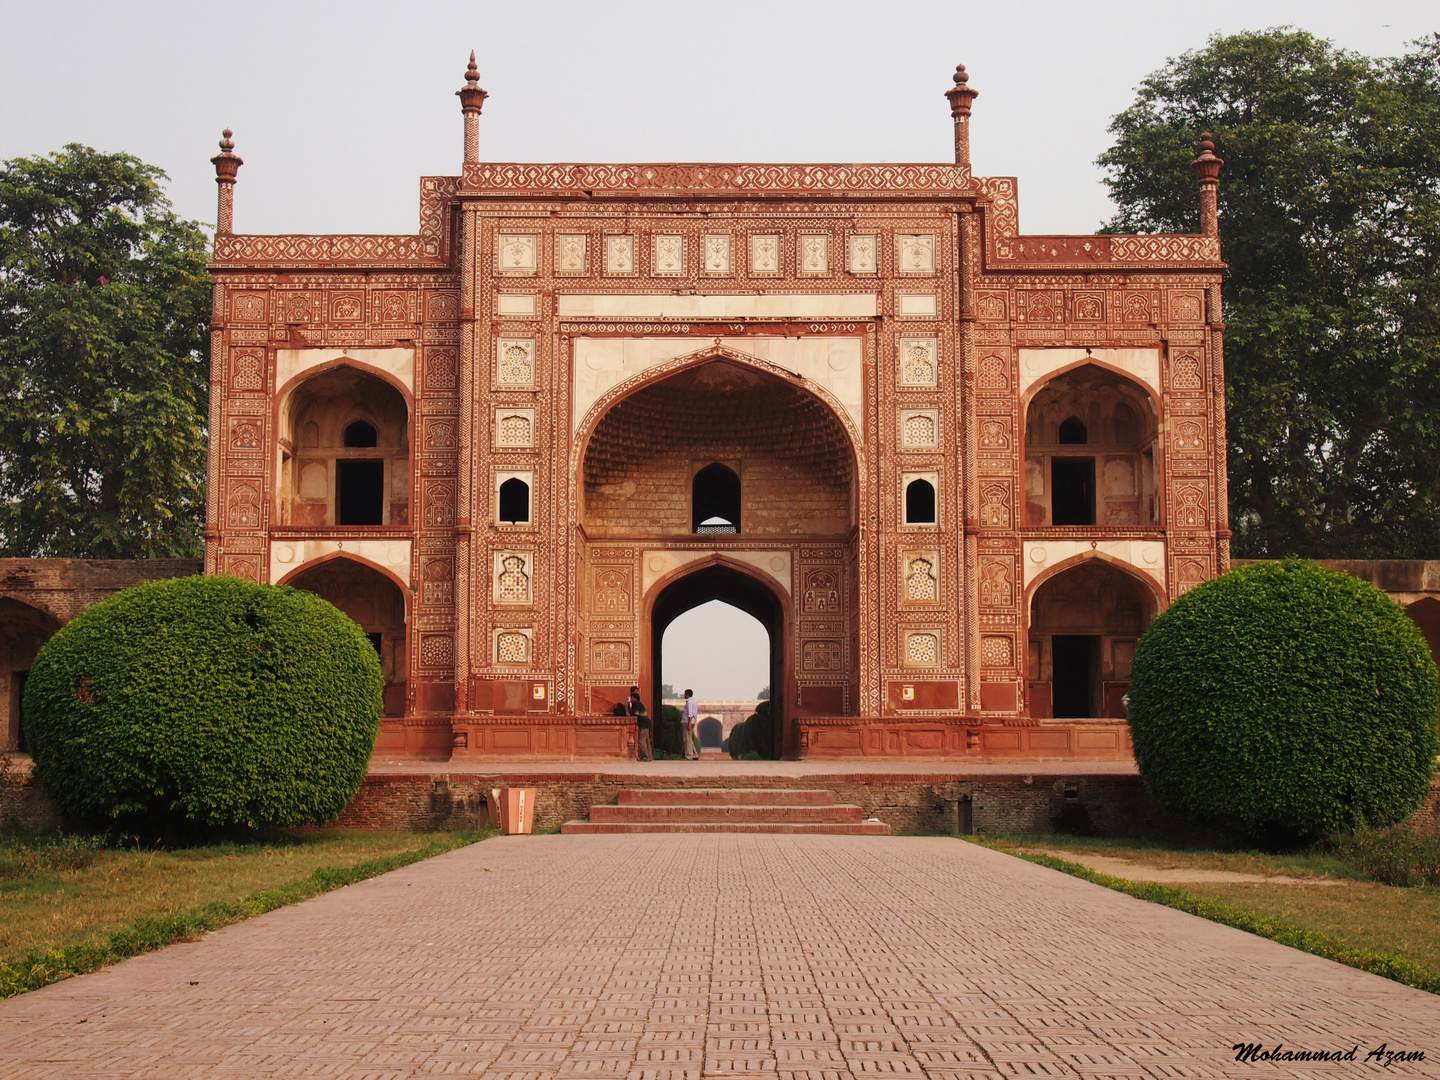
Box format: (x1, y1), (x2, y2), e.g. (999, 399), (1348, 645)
(1099, 29), (1440, 557)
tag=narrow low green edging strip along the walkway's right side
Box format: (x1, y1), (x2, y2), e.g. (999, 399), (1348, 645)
(963, 837), (1440, 994)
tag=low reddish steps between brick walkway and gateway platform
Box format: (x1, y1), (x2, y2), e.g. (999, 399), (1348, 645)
(560, 788), (890, 837)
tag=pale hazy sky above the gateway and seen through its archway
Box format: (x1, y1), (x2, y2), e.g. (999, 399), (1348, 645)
(0, 0), (1440, 697)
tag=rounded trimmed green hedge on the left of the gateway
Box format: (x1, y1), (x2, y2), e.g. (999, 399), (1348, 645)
(24, 576), (384, 829)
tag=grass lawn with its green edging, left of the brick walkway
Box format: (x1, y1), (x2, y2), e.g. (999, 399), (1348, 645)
(0, 829), (494, 998)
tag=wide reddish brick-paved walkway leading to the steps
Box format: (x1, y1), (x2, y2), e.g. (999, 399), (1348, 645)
(0, 835), (1440, 1080)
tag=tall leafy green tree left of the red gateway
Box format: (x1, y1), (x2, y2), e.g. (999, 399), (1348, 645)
(0, 144), (210, 559)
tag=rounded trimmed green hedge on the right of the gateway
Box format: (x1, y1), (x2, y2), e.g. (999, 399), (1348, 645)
(1129, 560), (1440, 845)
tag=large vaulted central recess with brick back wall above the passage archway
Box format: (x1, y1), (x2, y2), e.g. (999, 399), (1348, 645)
(580, 356), (857, 537)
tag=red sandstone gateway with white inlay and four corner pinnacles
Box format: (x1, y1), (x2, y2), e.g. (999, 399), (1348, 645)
(206, 58), (1230, 759)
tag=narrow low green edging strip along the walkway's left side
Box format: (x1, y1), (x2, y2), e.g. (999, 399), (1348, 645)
(0, 829), (495, 998)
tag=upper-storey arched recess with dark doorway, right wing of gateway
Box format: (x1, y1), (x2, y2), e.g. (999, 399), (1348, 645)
(1024, 363), (1163, 528)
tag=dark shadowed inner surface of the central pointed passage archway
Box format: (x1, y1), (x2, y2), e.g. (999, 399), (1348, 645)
(649, 563), (785, 759)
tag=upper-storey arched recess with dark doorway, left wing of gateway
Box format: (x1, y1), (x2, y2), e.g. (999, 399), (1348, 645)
(278, 364), (410, 526)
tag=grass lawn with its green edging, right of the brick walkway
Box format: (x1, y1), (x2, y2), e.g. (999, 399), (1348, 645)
(963, 837), (1440, 994)
